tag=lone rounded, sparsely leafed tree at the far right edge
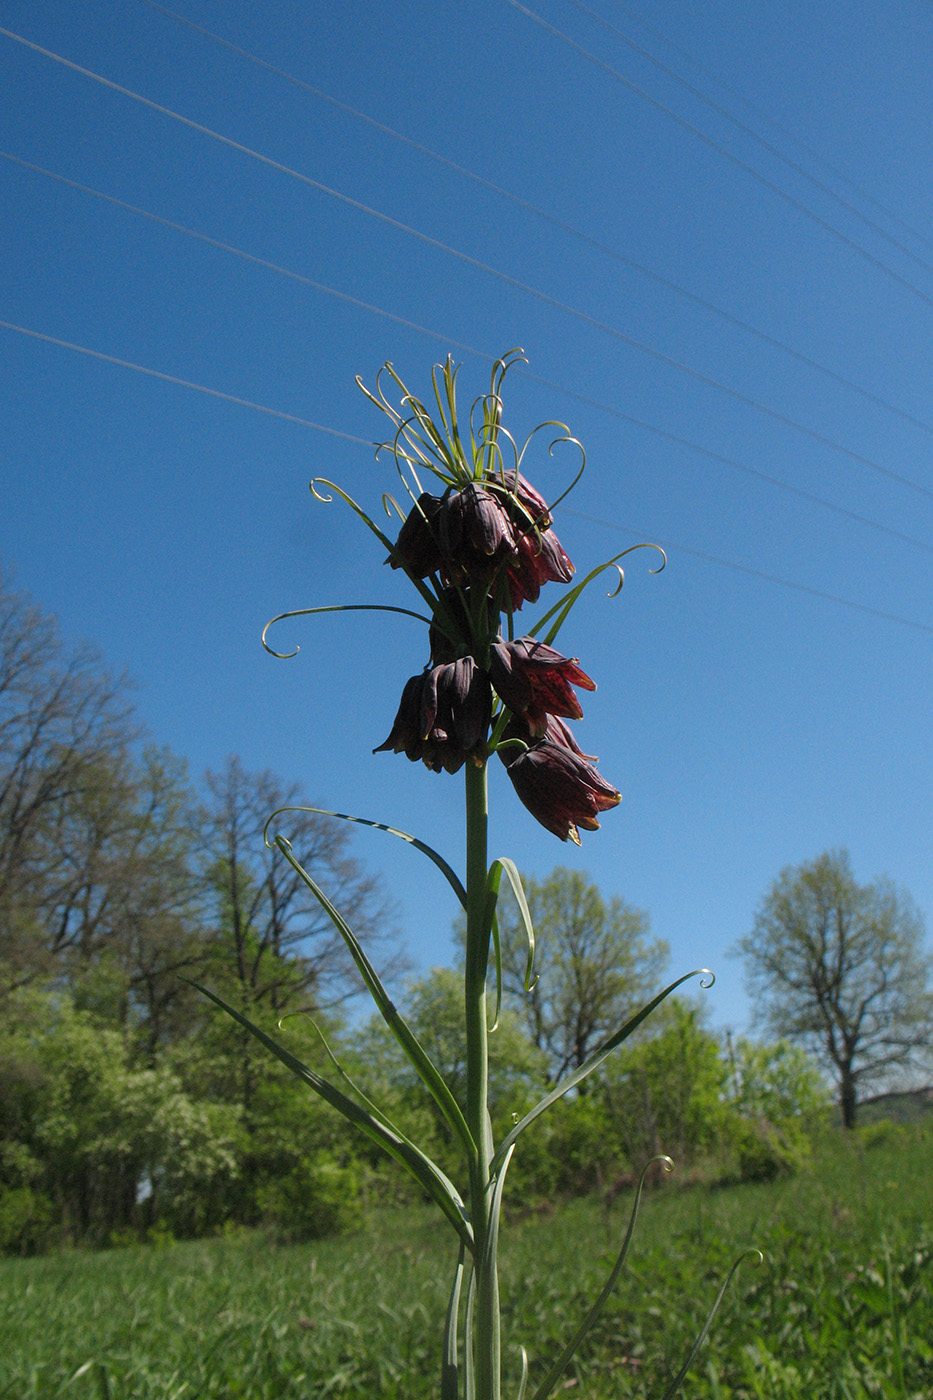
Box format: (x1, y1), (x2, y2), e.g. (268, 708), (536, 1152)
(738, 851), (933, 1128)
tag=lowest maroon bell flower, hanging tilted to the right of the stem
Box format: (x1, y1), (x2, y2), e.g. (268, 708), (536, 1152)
(506, 739), (622, 846)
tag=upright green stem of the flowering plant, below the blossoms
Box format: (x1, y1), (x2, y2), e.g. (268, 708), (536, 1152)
(464, 763), (500, 1400)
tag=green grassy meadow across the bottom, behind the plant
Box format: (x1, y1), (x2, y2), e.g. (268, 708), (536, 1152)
(0, 1124), (933, 1400)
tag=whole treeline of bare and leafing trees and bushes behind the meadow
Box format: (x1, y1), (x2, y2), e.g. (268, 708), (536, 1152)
(0, 571), (822, 1253)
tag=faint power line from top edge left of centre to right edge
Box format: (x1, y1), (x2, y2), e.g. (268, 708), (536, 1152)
(132, 0), (933, 434)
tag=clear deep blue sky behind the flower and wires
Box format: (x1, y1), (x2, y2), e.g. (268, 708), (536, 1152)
(0, 0), (933, 1028)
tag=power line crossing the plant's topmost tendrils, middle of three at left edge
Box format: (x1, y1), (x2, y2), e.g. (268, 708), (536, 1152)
(7, 143), (933, 553)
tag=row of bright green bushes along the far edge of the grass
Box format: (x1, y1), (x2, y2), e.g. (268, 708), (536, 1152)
(0, 969), (829, 1253)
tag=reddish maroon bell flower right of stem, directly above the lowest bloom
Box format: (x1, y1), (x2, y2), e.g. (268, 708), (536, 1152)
(489, 637), (595, 739)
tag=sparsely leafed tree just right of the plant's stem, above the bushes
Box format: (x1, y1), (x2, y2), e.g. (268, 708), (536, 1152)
(499, 867), (667, 1082)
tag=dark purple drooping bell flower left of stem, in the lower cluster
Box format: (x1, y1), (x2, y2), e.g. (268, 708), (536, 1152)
(373, 657), (492, 773)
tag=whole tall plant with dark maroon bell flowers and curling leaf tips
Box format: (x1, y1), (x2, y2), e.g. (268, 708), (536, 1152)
(196, 350), (756, 1400)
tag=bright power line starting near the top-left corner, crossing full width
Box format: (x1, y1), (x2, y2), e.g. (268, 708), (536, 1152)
(0, 27), (933, 498)
